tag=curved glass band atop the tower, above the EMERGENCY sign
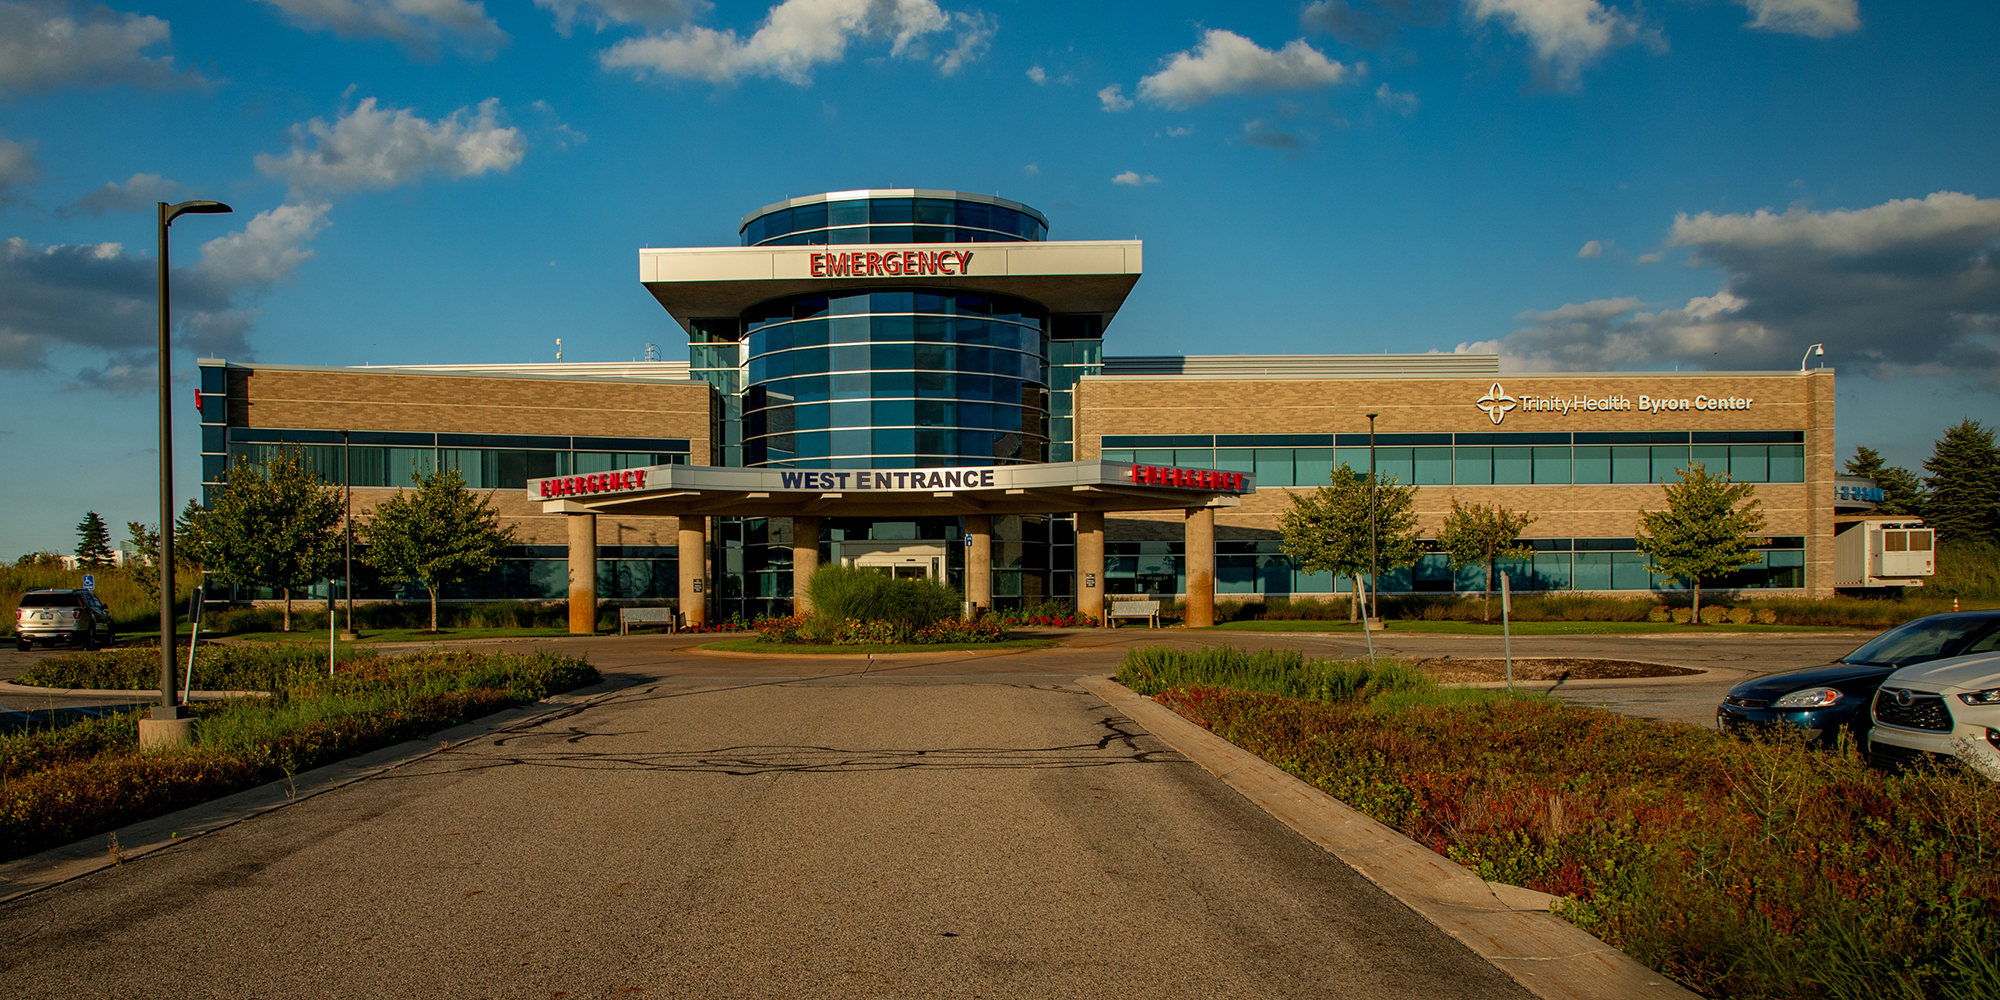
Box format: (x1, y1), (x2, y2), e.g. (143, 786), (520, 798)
(742, 198), (1048, 246)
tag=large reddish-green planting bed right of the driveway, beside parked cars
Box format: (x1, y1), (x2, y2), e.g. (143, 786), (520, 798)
(1120, 650), (2000, 1000)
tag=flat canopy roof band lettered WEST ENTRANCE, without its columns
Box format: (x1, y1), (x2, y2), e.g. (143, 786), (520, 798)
(528, 462), (1256, 518)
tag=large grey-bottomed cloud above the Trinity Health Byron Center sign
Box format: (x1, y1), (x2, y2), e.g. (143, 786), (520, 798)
(1460, 192), (2000, 386)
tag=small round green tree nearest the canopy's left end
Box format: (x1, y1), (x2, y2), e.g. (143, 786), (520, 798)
(360, 468), (514, 632)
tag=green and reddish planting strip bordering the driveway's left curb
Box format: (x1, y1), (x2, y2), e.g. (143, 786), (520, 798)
(0, 650), (598, 860)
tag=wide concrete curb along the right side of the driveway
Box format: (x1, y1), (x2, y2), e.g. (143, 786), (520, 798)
(1078, 676), (1696, 1000)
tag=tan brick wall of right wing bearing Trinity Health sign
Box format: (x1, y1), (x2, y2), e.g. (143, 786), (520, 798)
(1076, 372), (1836, 594)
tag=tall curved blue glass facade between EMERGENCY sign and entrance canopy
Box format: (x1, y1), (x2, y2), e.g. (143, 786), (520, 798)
(744, 290), (1048, 468)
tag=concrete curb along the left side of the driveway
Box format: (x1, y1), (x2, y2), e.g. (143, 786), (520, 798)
(0, 678), (636, 904)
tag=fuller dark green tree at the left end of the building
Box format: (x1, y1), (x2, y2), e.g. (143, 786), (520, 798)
(201, 452), (340, 632)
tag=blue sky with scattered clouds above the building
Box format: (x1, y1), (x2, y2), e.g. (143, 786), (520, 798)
(0, 0), (2000, 556)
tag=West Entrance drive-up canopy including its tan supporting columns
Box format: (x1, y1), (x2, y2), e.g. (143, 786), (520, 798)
(528, 462), (1256, 632)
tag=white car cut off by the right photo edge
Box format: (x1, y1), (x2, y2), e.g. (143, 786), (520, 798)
(1868, 652), (2000, 778)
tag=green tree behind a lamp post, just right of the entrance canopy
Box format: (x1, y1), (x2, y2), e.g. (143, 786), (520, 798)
(1278, 466), (1422, 620)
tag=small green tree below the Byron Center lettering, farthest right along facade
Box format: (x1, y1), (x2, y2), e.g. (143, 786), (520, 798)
(1638, 462), (1766, 622)
